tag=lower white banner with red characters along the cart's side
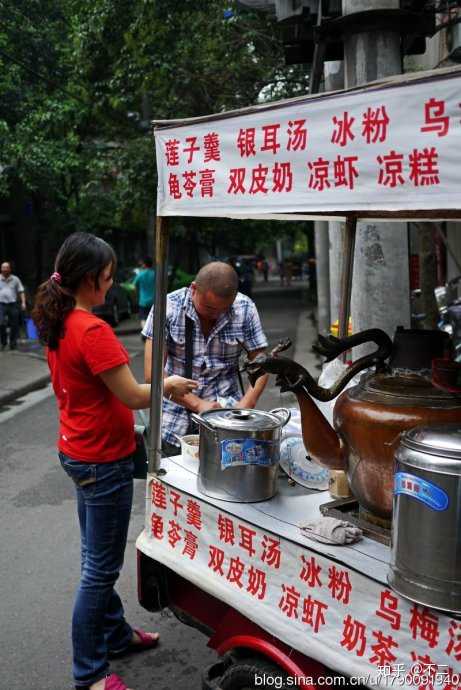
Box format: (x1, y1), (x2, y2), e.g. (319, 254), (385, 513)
(140, 479), (461, 690)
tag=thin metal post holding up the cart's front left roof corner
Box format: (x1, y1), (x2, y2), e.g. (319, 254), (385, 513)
(148, 216), (168, 474)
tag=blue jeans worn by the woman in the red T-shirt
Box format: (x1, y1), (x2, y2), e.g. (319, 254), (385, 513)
(59, 453), (134, 687)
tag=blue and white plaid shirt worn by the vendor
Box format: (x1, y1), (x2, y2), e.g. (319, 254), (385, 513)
(143, 288), (267, 445)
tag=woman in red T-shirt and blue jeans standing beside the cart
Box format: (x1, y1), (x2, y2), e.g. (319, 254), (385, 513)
(33, 233), (196, 690)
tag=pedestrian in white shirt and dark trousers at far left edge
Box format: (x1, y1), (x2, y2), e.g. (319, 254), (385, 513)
(0, 261), (26, 350)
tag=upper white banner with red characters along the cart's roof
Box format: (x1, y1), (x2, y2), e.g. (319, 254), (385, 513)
(155, 73), (461, 216)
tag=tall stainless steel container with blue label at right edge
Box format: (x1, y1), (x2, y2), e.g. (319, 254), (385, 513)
(388, 424), (461, 613)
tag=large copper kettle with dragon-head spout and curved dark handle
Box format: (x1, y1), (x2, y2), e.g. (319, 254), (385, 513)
(244, 327), (461, 520)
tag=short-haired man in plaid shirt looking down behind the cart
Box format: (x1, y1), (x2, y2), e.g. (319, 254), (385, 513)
(143, 261), (267, 455)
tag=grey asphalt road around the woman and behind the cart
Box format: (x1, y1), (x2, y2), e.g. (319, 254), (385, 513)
(0, 293), (310, 690)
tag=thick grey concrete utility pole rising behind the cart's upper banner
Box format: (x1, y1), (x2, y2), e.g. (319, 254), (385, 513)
(343, 0), (410, 358)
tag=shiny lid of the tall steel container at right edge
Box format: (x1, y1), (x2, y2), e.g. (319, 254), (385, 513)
(401, 424), (461, 474)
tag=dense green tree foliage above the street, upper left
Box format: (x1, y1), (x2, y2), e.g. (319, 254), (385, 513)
(0, 0), (306, 251)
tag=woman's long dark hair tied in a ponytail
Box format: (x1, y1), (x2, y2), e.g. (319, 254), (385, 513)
(32, 232), (117, 350)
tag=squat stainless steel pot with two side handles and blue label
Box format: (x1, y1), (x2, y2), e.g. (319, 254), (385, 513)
(192, 408), (291, 503)
